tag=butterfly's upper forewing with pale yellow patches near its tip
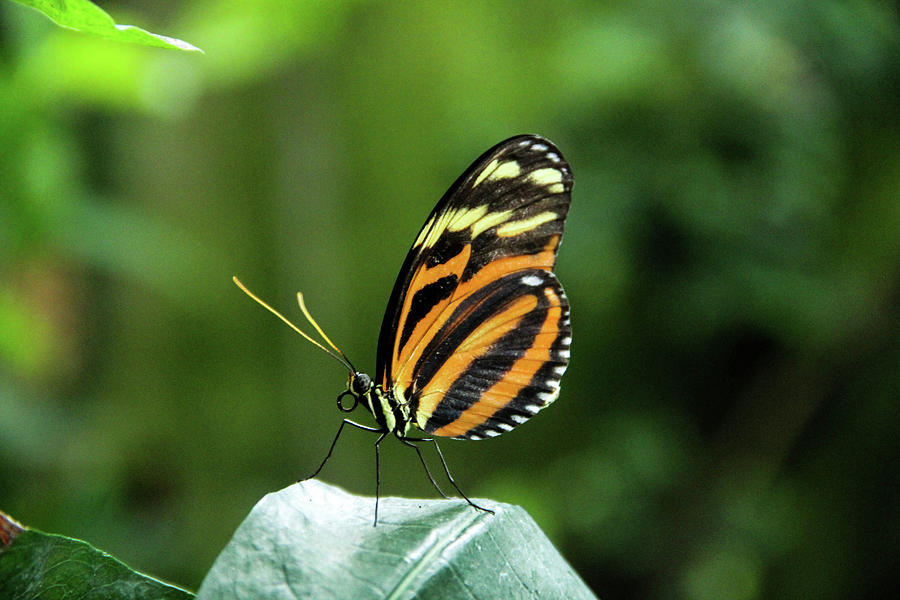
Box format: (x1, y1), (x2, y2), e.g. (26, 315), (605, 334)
(376, 135), (573, 394)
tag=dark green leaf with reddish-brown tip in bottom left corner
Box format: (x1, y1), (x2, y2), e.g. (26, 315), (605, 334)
(0, 512), (194, 600)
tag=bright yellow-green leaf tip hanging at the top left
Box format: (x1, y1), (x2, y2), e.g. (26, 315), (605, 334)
(15, 0), (202, 52)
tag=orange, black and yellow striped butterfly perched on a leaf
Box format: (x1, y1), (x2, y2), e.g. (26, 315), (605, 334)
(234, 135), (573, 525)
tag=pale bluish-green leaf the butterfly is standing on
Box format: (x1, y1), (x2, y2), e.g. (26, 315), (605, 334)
(197, 481), (594, 600)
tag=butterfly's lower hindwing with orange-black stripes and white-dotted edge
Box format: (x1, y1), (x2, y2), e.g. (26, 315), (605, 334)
(410, 269), (571, 439)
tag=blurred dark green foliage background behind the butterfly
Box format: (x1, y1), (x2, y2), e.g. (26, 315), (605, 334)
(0, 0), (900, 599)
